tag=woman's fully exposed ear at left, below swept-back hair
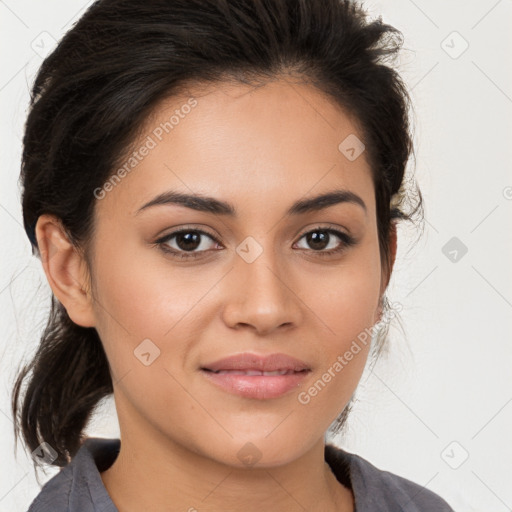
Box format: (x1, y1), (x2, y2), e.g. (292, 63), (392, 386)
(35, 214), (95, 327)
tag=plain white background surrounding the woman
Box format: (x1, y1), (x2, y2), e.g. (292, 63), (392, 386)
(0, 0), (512, 512)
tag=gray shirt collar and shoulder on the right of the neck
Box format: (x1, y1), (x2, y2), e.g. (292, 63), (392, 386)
(325, 444), (454, 512)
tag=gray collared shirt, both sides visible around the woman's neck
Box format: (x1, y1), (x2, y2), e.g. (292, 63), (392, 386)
(28, 438), (454, 512)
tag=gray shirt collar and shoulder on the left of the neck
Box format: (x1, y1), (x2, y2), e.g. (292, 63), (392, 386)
(27, 438), (119, 512)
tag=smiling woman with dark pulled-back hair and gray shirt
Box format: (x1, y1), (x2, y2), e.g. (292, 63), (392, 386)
(13, 0), (451, 512)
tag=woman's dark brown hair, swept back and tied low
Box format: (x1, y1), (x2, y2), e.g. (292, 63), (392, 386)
(12, 0), (422, 466)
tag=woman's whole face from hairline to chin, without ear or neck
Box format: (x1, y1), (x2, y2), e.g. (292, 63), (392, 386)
(85, 80), (386, 466)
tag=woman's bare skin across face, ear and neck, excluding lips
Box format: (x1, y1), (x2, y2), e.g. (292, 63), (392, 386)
(36, 79), (396, 512)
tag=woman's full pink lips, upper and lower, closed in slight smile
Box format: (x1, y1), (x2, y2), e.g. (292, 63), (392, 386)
(201, 353), (311, 400)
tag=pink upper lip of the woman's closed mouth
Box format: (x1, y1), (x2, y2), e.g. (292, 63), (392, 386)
(202, 352), (310, 372)
